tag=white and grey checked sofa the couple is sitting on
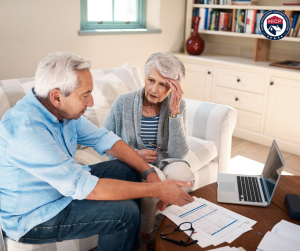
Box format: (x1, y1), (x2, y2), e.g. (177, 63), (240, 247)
(0, 63), (237, 251)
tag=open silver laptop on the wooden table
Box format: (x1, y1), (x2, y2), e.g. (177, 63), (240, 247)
(217, 140), (285, 207)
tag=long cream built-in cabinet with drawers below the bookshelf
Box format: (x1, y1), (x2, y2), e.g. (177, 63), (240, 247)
(176, 54), (300, 155)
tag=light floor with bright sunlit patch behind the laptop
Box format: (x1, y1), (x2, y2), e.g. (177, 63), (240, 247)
(230, 137), (300, 176)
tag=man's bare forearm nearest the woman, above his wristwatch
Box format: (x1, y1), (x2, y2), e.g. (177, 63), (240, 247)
(106, 140), (149, 174)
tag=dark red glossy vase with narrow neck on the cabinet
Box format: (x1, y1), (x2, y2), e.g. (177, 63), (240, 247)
(185, 17), (205, 55)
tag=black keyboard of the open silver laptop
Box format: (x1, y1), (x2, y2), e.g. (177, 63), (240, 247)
(236, 176), (262, 202)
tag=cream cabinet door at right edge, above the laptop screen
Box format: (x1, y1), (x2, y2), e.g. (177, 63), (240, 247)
(265, 77), (300, 144)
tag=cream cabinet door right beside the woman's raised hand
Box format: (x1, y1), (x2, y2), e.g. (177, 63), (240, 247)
(183, 63), (213, 101)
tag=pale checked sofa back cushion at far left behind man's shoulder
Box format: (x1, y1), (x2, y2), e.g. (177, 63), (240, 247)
(0, 82), (35, 120)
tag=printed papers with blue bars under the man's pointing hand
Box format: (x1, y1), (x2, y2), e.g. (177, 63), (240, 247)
(162, 197), (256, 248)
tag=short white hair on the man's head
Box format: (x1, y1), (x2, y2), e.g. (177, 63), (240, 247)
(34, 52), (91, 98)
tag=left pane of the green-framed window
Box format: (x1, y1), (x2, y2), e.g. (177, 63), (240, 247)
(88, 0), (113, 21)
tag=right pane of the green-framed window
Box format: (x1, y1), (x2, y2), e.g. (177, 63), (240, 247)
(115, 0), (138, 21)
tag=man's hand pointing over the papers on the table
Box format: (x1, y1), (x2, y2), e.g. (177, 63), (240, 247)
(156, 180), (194, 207)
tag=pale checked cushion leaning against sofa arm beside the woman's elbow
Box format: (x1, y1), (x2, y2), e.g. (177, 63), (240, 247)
(184, 136), (218, 173)
